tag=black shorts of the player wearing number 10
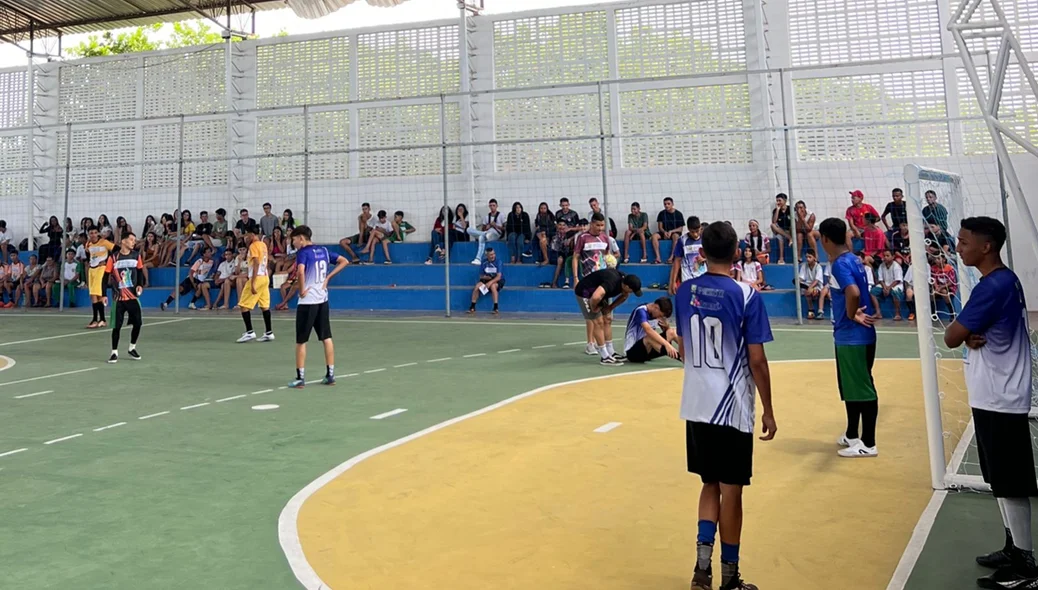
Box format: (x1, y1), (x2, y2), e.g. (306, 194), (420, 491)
(685, 422), (754, 486)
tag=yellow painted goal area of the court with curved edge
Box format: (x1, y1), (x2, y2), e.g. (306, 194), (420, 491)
(298, 360), (959, 590)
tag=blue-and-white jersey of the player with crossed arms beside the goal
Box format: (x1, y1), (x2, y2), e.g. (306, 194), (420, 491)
(958, 267), (1031, 413)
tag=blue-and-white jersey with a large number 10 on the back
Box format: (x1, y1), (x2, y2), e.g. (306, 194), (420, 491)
(675, 273), (773, 432)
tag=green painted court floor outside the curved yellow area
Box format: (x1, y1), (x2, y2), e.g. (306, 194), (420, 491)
(0, 313), (954, 590)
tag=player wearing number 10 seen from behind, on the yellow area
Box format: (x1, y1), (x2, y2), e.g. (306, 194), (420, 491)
(675, 221), (775, 590)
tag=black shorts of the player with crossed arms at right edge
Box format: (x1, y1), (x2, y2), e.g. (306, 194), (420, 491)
(973, 408), (1038, 498)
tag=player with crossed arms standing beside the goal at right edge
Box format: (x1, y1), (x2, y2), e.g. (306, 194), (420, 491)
(945, 217), (1038, 589)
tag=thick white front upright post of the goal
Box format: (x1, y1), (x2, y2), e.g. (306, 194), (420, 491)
(904, 164), (948, 489)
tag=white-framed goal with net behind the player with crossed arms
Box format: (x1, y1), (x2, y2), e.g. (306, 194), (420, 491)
(905, 165), (1038, 491)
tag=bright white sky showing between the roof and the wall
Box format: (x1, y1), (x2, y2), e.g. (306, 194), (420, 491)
(0, 0), (603, 68)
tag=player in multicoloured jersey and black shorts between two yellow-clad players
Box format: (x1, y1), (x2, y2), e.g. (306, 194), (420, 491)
(105, 232), (144, 364)
